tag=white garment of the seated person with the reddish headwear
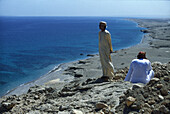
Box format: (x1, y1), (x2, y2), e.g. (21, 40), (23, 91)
(124, 59), (154, 84)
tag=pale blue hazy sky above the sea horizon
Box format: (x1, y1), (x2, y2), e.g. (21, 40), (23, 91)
(0, 0), (170, 17)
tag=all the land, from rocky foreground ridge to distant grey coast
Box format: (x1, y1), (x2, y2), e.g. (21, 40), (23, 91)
(0, 19), (170, 114)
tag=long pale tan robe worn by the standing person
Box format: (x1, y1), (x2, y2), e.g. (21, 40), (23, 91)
(99, 30), (114, 78)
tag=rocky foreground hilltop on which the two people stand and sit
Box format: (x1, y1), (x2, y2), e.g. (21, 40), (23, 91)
(0, 62), (170, 114)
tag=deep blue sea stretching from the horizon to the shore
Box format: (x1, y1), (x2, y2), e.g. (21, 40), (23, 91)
(0, 17), (143, 96)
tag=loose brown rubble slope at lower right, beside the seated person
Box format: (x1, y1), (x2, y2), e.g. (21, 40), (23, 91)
(116, 62), (170, 114)
